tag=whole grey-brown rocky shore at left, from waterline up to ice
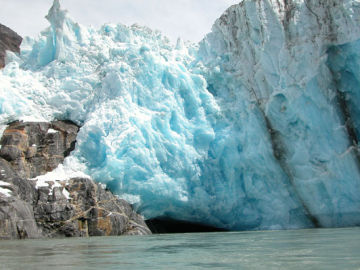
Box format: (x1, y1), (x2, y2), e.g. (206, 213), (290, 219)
(0, 121), (151, 239)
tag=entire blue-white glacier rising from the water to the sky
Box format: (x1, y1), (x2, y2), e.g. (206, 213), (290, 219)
(0, 0), (360, 230)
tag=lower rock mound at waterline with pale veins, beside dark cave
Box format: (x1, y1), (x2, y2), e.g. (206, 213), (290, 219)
(34, 178), (150, 237)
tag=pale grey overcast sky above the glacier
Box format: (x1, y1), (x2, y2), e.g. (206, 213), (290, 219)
(0, 0), (240, 41)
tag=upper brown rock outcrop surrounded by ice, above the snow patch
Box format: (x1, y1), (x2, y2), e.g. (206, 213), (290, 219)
(0, 121), (79, 178)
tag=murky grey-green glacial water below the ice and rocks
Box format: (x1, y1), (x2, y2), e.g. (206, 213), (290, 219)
(0, 228), (360, 270)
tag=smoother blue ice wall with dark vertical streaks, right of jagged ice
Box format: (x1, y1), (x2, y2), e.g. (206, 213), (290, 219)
(200, 0), (360, 226)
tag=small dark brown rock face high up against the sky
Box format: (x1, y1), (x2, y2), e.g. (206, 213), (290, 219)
(0, 24), (22, 68)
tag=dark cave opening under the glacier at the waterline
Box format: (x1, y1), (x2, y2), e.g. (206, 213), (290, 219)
(145, 217), (228, 234)
